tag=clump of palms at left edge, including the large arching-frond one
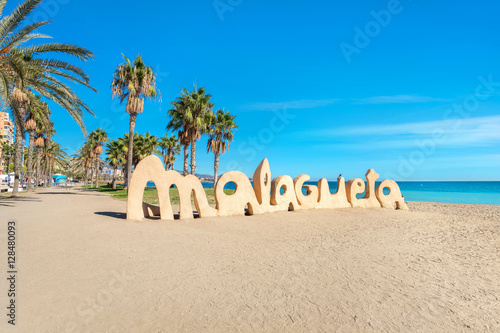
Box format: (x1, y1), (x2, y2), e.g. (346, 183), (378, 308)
(0, 0), (95, 196)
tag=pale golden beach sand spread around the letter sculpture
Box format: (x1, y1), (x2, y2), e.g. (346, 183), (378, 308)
(0, 185), (500, 332)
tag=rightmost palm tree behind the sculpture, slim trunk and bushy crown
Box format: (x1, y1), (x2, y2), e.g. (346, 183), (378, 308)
(206, 109), (238, 187)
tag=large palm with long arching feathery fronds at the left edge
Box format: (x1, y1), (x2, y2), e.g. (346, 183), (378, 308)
(0, 0), (95, 196)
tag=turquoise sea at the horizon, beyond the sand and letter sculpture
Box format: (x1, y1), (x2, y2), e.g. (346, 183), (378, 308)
(148, 181), (500, 205)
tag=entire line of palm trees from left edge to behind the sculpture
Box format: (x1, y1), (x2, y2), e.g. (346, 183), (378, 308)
(0, 0), (237, 196)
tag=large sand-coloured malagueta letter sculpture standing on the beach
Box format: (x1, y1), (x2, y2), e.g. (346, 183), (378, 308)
(127, 156), (408, 220)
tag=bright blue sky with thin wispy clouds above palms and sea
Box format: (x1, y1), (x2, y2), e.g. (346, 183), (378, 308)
(7, 0), (500, 180)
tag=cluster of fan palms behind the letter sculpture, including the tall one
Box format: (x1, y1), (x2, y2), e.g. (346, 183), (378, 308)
(74, 55), (237, 189)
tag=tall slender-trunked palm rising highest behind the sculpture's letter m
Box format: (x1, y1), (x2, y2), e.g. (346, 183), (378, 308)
(111, 54), (161, 189)
